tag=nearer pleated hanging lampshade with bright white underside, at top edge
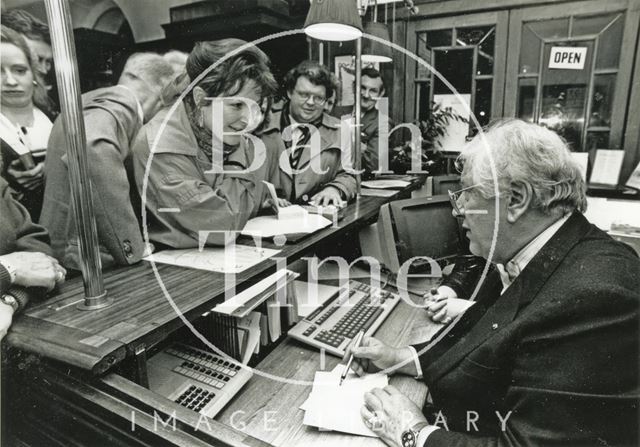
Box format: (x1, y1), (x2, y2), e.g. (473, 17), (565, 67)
(304, 0), (362, 42)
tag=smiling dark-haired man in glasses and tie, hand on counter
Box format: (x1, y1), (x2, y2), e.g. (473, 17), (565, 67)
(262, 61), (356, 205)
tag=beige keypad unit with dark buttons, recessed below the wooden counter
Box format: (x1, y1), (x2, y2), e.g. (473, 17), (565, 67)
(147, 343), (253, 418)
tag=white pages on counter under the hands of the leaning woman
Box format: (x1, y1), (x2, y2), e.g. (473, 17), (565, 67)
(241, 213), (331, 237)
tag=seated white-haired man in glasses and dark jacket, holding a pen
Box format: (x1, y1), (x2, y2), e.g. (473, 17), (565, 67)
(347, 120), (640, 447)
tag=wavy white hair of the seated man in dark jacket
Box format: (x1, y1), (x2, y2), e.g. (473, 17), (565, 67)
(460, 119), (587, 214)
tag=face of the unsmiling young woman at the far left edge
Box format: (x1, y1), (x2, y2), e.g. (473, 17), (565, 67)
(0, 42), (34, 107)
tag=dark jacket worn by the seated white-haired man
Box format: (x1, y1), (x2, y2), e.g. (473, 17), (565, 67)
(416, 213), (640, 447)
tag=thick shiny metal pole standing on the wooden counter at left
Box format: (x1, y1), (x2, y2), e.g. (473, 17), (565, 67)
(45, 0), (113, 310)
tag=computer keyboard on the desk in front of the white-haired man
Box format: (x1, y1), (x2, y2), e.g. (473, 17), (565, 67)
(288, 281), (400, 357)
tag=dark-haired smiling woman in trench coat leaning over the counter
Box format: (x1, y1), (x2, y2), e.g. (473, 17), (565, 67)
(133, 39), (277, 248)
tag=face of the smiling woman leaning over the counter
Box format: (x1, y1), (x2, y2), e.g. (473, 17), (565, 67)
(202, 79), (263, 146)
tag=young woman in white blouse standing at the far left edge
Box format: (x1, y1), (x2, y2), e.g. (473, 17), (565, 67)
(0, 25), (53, 221)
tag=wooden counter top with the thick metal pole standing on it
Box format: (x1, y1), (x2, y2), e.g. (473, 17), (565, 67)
(7, 184), (415, 374)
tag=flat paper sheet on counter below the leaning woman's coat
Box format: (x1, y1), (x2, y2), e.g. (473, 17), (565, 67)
(143, 245), (280, 273)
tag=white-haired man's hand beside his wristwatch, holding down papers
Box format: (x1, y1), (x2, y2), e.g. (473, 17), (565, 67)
(360, 385), (426, 447)
